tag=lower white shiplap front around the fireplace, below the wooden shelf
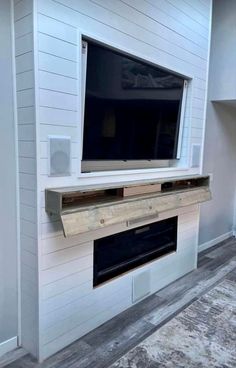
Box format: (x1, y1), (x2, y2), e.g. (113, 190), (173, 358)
(40, 206), (199, 358)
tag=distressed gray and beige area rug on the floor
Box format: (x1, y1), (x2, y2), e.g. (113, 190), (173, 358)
(110, 279), (236, 368)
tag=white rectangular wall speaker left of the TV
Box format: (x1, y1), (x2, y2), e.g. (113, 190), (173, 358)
(48, 136), (71, 176)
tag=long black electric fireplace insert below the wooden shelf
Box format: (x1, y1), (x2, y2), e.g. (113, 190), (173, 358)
(93, 216), (178, 286)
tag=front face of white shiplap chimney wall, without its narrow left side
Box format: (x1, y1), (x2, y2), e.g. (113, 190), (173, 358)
(33, 0), (211, 359)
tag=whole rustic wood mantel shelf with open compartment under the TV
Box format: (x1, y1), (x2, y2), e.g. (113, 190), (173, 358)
(45, 175), (211, 237)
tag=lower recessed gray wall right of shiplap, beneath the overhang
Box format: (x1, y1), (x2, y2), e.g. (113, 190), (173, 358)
(199, 102), (236, 244)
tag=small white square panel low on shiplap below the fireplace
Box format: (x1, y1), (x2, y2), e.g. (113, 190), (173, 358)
(132, 270), (151, 303)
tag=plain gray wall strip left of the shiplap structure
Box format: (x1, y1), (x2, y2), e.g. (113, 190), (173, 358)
(0, 0), (18, 348)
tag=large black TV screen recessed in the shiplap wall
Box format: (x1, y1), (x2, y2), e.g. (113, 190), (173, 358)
(82, 42), (184, 161)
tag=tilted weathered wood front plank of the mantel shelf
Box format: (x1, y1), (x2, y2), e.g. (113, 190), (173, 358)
(61, 187), (211, 236)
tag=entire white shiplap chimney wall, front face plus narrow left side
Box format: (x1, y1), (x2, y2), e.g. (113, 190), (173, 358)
(12, 0), (211, 360)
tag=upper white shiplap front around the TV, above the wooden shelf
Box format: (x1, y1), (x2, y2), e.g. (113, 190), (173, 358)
(35, 0), (211, 190)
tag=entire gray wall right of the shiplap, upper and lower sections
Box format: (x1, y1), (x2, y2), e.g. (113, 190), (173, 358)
(199, 0), (236, 246)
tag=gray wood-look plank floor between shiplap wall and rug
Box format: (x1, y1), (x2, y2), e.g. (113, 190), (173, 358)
(0, 237), (236, 368)
